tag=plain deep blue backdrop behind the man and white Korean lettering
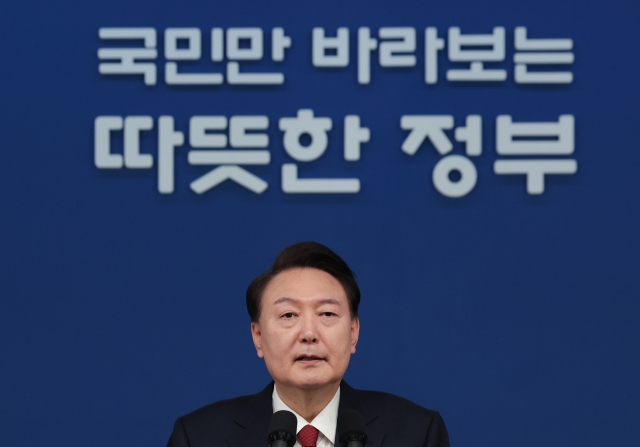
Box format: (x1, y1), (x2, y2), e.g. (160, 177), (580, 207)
(0, 0), (640, 447)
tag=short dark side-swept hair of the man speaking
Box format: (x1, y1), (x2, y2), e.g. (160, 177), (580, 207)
(247, 242), (360, 322)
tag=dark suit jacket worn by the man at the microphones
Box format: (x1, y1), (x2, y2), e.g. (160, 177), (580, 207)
(167, 381), (449, 447)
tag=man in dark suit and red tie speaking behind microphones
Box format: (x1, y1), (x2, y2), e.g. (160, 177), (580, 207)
(168, 242), (449, 447)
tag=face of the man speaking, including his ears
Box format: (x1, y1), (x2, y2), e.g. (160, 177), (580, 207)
(251, 268), (360, 389)
